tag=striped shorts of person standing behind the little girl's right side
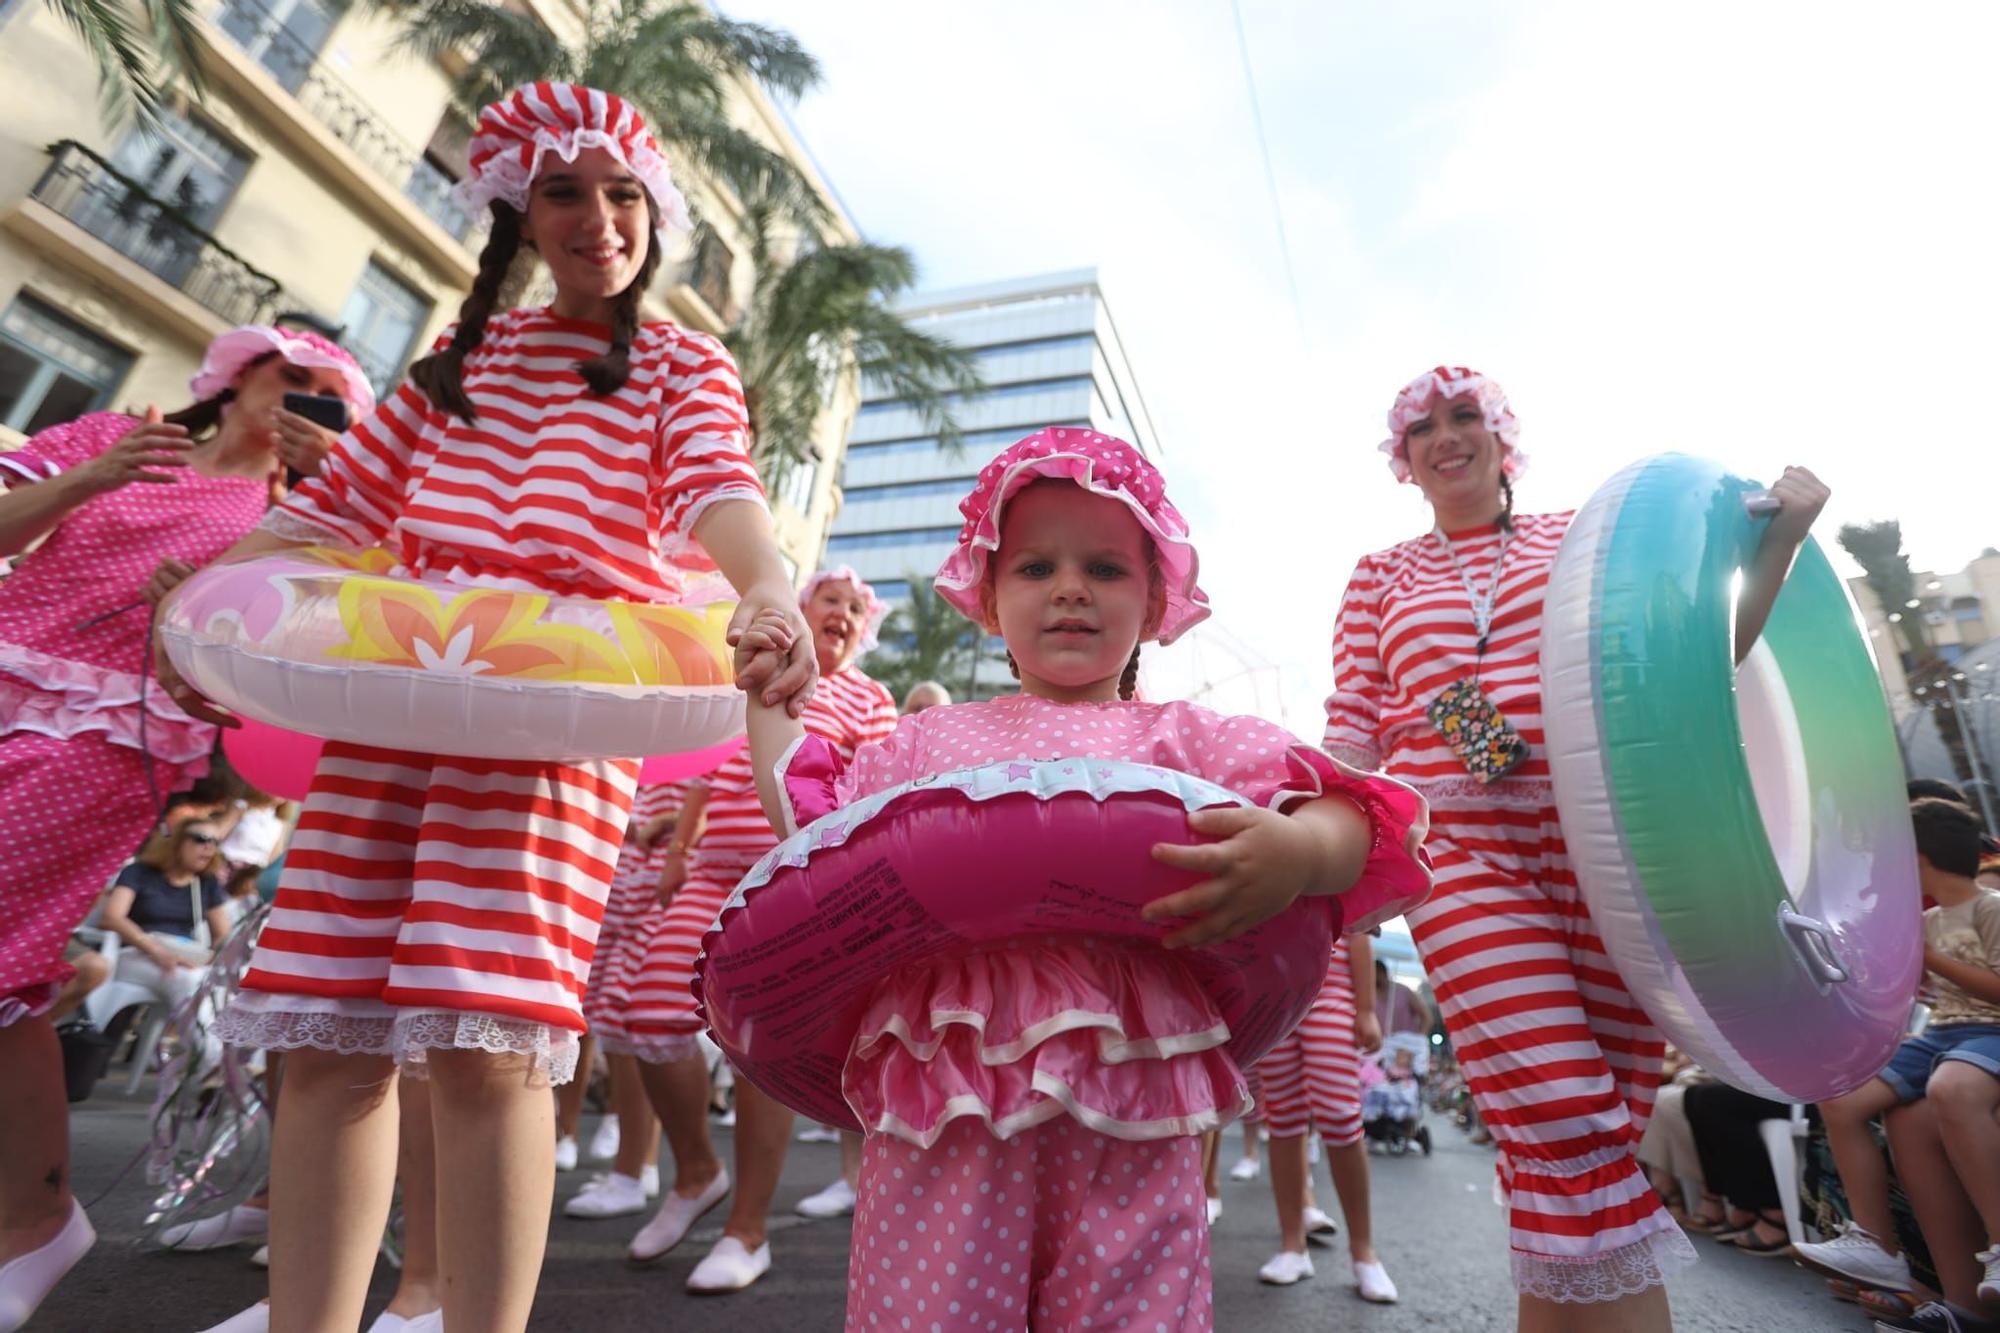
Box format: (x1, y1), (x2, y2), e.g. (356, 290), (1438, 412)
(1256, 939), (1362, 1147)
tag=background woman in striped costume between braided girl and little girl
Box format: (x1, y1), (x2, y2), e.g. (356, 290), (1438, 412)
(604, 566), (896, 1291)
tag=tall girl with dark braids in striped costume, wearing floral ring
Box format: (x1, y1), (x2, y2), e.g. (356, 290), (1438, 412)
(162, 84), (814, 1329)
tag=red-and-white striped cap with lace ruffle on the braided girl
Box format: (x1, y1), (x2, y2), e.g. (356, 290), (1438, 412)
(452, 84), (694, 234)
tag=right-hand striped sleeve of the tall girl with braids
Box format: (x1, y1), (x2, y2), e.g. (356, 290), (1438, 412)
(654, 330), (764, 536)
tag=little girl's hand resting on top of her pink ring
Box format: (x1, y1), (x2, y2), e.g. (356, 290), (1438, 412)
(1140, 807), (1320, 949)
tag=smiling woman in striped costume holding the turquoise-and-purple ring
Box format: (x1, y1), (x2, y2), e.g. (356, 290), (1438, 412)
(1326, 366), (1826, 1329)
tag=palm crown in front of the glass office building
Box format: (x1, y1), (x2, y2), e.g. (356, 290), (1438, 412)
(722, 187), (984, 484)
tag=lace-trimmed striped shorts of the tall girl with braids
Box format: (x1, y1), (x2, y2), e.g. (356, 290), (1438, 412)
(218, 741), (638, 1083)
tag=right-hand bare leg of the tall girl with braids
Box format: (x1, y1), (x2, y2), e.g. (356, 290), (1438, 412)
(430, 1051), (556, 1333)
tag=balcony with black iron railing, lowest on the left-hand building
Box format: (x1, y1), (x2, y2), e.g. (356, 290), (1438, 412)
(30, 140), (284, 324)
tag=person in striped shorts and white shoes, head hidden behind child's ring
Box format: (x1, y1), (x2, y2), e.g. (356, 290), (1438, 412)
(1256, 935), (1396, 1303)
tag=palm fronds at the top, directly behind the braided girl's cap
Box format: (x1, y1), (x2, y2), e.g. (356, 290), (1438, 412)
(382, 0), (828, 222)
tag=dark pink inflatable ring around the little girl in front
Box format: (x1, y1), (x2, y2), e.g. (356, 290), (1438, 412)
(694, 759), (1340, 1129)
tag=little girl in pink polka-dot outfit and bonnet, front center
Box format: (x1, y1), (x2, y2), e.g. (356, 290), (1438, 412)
(738, 428), (1430, 1331)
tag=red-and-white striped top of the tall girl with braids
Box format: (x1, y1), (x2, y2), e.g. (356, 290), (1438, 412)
(266, 310), (764, 602)
